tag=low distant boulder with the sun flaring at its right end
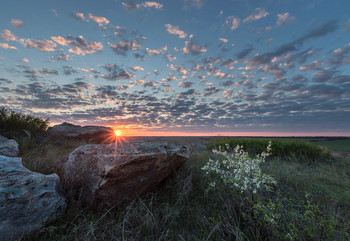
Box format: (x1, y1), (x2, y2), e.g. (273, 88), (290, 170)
(47, 122), (115, 143)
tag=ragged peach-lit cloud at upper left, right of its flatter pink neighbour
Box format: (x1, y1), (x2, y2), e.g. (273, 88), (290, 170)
(51, 35), (103, 55)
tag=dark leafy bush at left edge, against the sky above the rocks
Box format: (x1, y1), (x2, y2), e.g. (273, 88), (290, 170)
(0, 107), (49, 132)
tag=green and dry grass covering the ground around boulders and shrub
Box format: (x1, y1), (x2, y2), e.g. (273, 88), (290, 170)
(13, 135), (350, 240)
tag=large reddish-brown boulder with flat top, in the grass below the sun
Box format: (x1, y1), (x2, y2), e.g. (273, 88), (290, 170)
(62, 142), (190, 209)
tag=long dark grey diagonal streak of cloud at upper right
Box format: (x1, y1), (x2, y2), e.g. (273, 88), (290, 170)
(251, 21), (337, 65)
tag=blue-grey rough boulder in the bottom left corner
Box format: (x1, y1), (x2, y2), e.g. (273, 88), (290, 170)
(0, 155), (67, 241)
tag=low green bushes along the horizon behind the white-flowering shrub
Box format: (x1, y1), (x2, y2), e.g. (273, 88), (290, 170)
(207, 138), (332, 162)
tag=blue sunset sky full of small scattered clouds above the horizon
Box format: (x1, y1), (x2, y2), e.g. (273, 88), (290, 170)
(0, 0), (350, 136)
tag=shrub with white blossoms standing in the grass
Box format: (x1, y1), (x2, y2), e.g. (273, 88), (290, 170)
(202, 142), (277, 194)
